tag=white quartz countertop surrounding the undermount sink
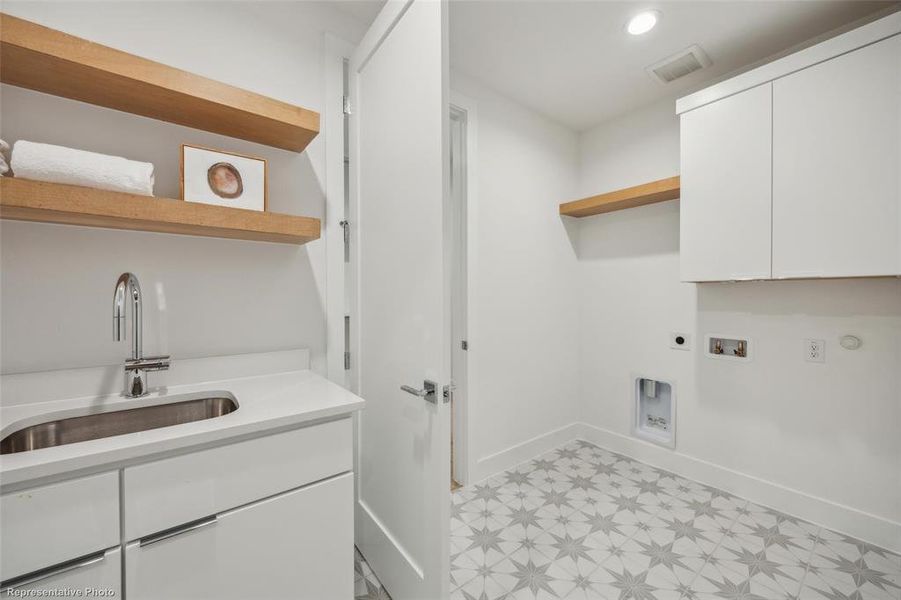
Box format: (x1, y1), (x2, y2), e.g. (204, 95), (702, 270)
(0, 370), (364, 487)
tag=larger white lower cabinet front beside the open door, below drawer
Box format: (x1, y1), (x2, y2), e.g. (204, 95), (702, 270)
(125, 473), (353, 600)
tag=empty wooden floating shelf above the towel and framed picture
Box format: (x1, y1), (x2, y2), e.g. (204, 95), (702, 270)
(0, 13), (319, 152)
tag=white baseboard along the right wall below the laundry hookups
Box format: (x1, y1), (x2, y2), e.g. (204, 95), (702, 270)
(572, 423), (901, 552)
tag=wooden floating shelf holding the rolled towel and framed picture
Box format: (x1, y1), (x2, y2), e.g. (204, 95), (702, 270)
(0, 177), (320, 244)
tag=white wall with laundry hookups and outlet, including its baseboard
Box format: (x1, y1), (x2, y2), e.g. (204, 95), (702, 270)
(576, 102), (901, 549)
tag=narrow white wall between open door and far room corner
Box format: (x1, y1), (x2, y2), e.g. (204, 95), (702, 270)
(451, 72), (579, 481)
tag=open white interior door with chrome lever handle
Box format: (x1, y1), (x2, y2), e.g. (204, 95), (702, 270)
(350, 0), (450, 600)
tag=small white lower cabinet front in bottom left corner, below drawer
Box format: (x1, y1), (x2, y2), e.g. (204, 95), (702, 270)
(0, 548), (122, 600)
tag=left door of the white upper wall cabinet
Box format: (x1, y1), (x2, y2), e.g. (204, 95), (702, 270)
(679, 83), (772, 281)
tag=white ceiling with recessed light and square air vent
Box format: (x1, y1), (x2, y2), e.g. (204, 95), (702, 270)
(450, 0), (897, 131)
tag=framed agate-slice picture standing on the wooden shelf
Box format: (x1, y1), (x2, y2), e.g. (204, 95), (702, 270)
(180, 144), (269, 212)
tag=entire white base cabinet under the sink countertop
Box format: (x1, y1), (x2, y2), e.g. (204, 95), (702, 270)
(0, 415), (354, 600)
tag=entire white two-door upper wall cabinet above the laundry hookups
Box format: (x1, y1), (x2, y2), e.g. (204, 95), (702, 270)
(676, 13), (901, 281)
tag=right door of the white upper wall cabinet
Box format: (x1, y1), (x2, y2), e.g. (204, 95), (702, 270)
(773, 36), (901, 278)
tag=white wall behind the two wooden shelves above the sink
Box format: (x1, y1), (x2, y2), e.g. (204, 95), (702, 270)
(0, 2), (363, 373)
